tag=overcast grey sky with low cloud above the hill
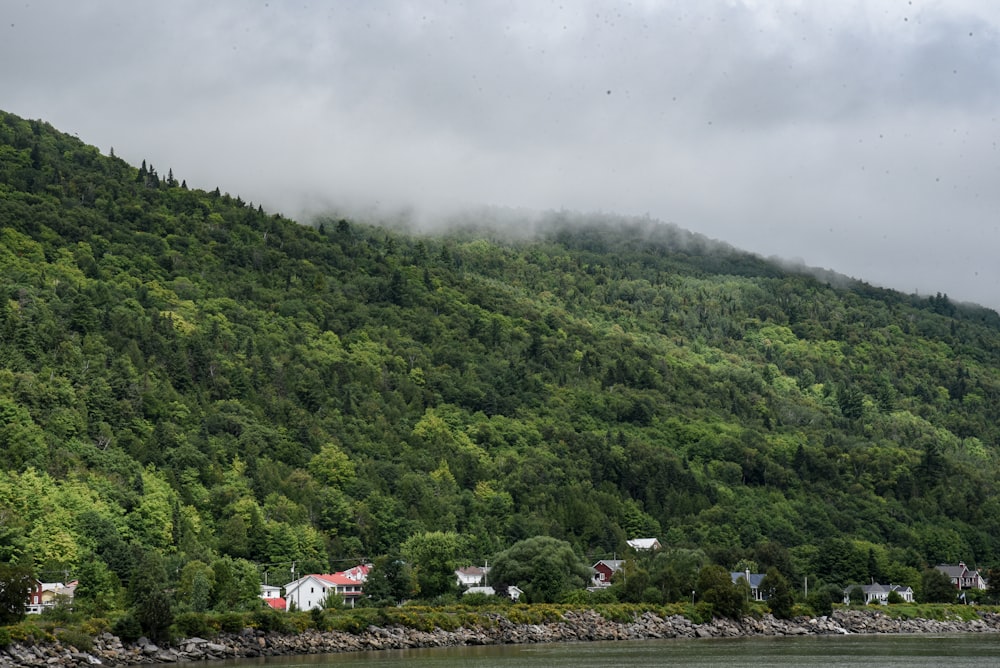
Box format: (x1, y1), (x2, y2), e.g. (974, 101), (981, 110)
(0, 0), (1000, 308)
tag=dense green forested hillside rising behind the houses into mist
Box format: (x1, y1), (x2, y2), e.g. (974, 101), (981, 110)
(0, 109), (1000, 596)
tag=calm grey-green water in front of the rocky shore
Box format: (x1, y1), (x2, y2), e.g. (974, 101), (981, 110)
(199, 634), (1000, 668)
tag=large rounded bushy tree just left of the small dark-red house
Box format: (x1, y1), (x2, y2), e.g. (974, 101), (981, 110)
(490, 536), (590, 603)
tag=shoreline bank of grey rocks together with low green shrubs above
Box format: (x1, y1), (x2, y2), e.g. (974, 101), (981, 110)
(0, 604), (1000, 668)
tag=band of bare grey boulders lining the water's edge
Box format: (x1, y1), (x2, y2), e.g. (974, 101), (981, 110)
(0, 609), (1000, 668)
